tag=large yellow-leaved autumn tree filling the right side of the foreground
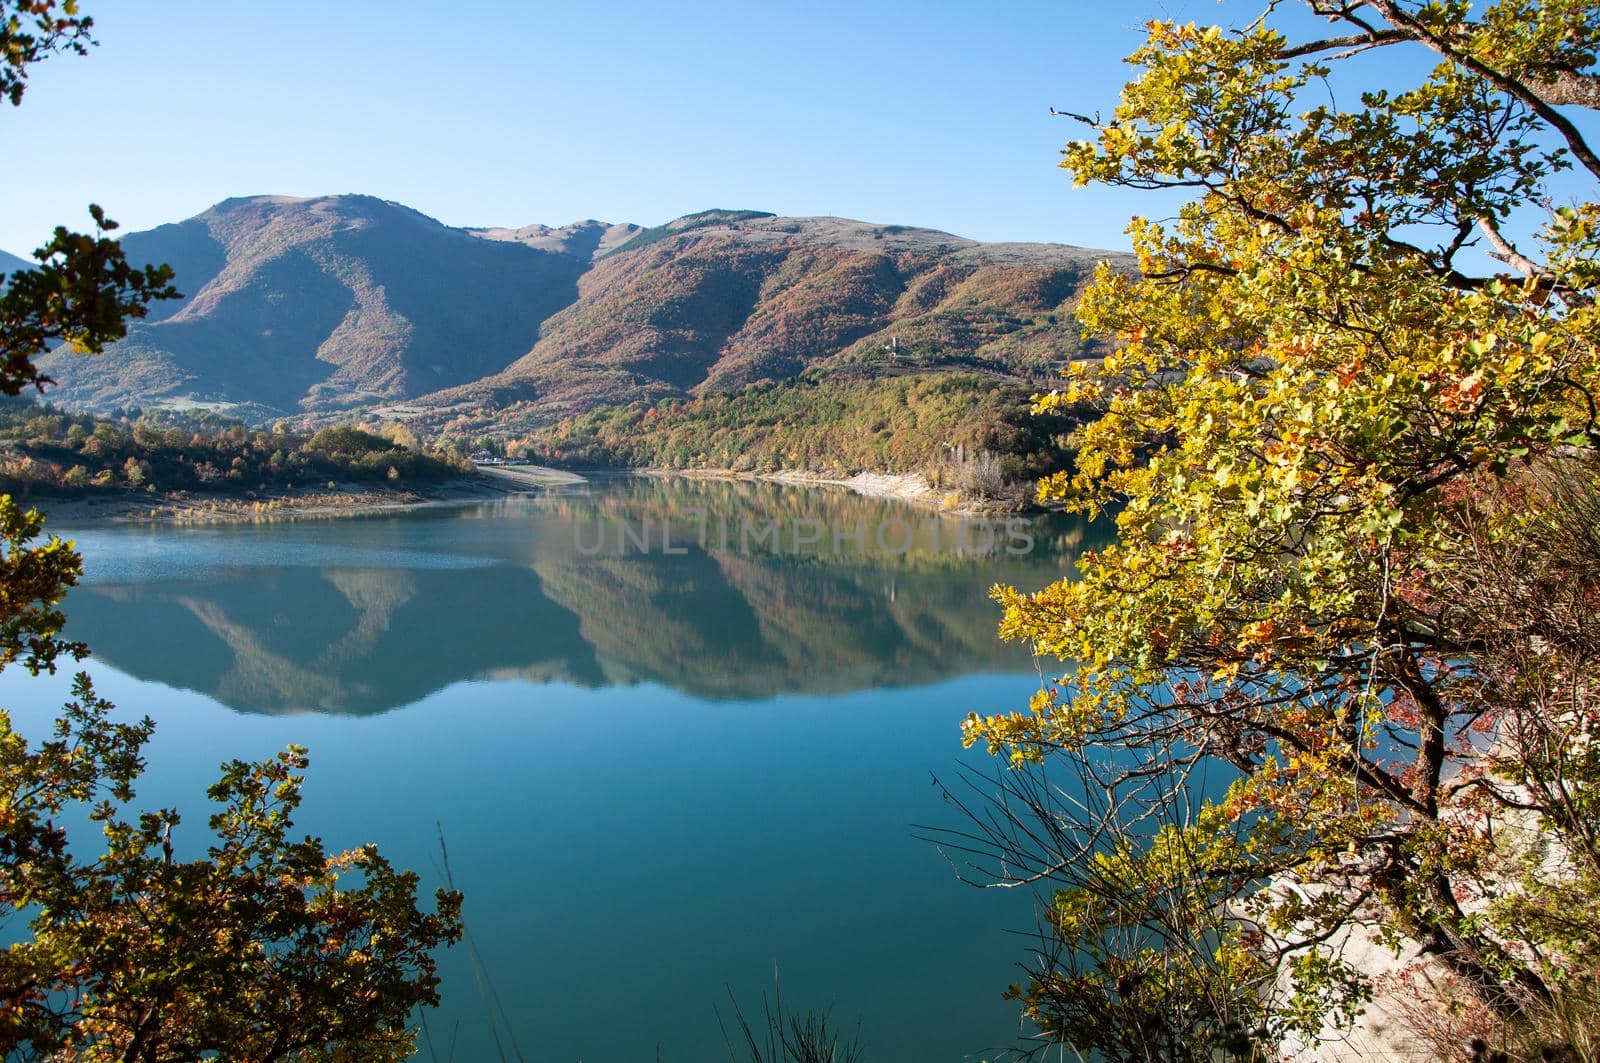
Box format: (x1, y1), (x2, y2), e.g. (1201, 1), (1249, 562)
(965, 0), (1600, 1058)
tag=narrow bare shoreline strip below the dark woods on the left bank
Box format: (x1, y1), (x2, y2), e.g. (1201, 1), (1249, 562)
(18, 466), (586, 528)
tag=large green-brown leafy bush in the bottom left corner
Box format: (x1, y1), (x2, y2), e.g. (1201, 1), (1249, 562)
(0, 674), (461, 1060)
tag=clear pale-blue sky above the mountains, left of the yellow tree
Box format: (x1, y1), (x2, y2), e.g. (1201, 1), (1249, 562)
(0, 0), (1292, 255)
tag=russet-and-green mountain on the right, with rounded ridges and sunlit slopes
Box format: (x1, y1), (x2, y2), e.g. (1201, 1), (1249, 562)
(418, 211), (1118, 423)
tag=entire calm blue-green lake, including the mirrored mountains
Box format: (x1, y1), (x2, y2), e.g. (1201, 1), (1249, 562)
(0, 477), (1091, 1063)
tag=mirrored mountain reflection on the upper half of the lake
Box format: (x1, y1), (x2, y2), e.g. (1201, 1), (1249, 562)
(64, 477), (1099, 714)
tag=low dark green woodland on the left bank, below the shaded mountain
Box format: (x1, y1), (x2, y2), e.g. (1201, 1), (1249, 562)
(0, 399), (470, 498)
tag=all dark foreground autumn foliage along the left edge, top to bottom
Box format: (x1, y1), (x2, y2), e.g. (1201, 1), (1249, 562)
(0, 0), (461, 1063)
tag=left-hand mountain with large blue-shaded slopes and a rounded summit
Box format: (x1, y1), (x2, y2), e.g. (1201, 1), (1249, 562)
(45, 195), (589, 416)
